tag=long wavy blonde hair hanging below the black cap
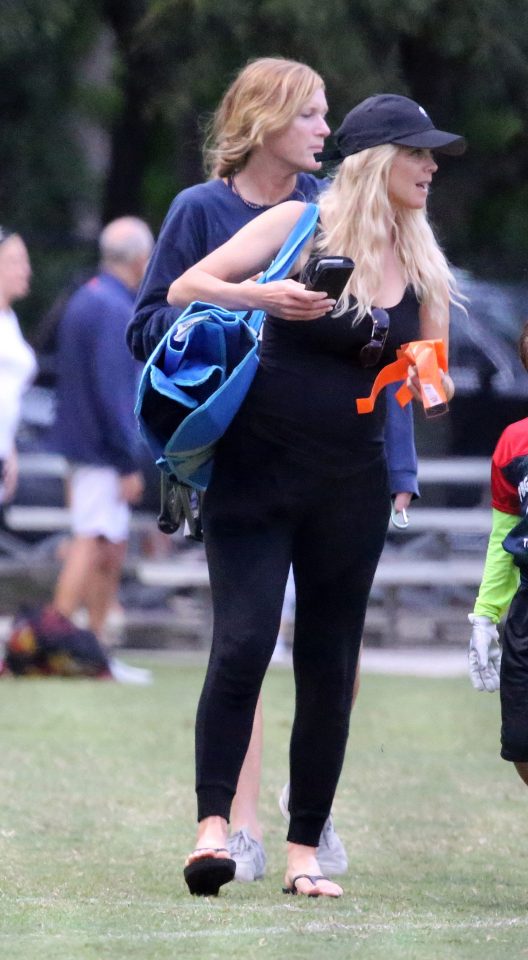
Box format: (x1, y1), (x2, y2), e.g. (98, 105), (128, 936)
(317, 144), (460, 322)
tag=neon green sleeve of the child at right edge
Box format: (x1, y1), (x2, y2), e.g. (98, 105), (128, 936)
(473, 508), (519, 623)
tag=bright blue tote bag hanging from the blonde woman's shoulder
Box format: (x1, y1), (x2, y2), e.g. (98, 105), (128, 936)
(135, 203), (319, 490)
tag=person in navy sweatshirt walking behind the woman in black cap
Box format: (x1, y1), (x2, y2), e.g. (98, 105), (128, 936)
(127, 58), (424, 881)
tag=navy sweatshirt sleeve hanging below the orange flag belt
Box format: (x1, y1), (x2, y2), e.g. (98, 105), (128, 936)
(385, 383), (420, 497)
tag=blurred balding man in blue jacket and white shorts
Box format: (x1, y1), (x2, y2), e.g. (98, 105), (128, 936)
(49, 217), (154, 682)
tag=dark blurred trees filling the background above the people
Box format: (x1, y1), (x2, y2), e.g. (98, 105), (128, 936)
(0, 0), (528, 331)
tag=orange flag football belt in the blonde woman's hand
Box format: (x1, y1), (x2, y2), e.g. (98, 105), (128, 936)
(356, 340), (447, 417)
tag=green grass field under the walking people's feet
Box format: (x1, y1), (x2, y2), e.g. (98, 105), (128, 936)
(0, 661), (528, 960)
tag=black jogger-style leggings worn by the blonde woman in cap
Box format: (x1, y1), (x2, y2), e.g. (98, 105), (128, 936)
(196, 437), (390, 846)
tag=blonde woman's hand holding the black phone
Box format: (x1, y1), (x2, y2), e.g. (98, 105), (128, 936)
(240, 279), (336, 320)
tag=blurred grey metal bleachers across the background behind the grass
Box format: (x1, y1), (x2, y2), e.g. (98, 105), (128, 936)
(0, 454), (491, 644)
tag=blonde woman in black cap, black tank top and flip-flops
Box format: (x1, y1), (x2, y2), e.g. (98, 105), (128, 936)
(169, 95), (464, 897)
